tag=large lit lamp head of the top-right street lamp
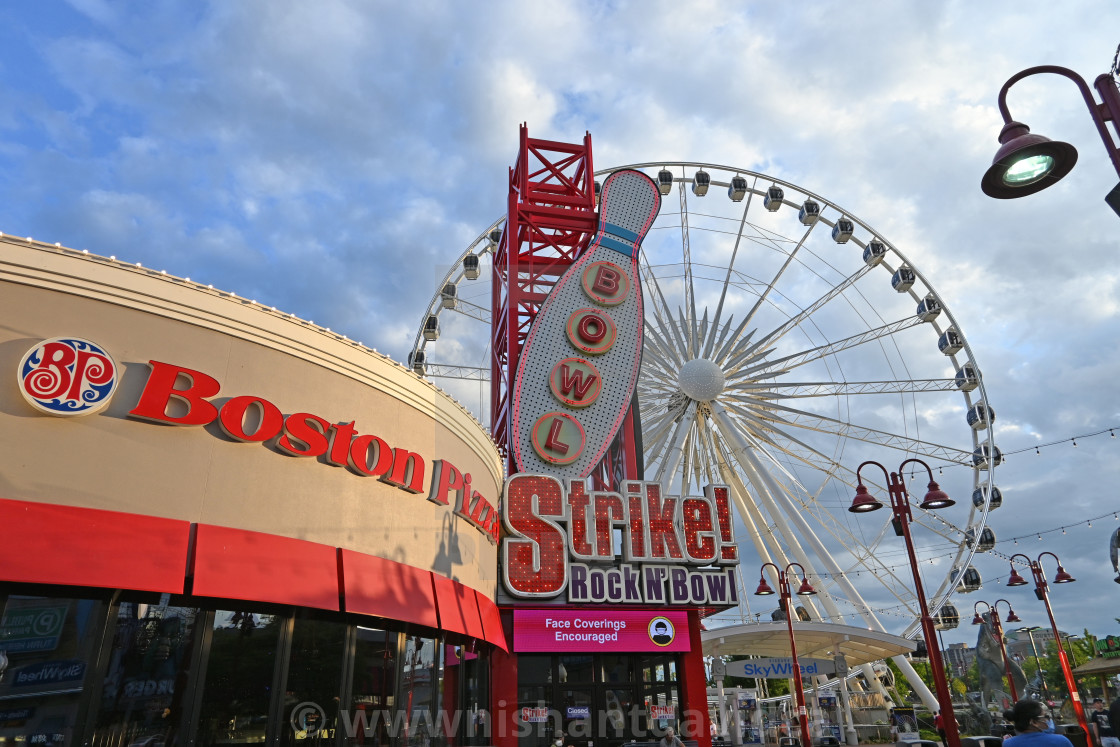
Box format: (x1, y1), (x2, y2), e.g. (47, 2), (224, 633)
(980, 122), (1077, 199)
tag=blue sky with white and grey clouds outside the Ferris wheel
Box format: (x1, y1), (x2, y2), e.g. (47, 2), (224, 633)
(0, 0), (1120, 643)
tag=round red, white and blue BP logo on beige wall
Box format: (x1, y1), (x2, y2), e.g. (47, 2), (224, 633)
(19, 337), (119, 417)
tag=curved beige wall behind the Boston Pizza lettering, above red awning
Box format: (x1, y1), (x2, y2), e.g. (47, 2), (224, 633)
(0, 237), (503, 599)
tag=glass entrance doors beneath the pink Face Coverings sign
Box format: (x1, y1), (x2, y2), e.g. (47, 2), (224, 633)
(517, 653), (680, 747)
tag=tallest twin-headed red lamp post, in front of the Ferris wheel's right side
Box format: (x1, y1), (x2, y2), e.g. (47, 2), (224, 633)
(848, 459), (961, 747)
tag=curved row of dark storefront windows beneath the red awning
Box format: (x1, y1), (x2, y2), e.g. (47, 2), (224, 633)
(0, 585), (491, 747)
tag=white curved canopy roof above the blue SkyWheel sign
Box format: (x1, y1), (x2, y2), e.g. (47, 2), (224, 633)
(700, 620), (913, 666)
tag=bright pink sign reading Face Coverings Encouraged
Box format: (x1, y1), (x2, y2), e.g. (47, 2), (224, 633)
(513, 609), (690, 653)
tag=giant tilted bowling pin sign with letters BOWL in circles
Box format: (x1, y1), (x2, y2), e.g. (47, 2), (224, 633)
(512, 170), (661, 479)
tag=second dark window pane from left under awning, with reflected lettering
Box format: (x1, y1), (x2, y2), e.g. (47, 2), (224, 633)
(93, 601), (199, 747)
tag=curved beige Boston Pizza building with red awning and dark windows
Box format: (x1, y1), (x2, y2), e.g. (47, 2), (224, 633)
(0, 237), (510, 747)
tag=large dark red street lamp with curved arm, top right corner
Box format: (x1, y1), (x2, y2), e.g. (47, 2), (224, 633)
(980, 65), (1120, 215)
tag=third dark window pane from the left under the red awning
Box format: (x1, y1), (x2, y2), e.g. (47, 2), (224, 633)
(198, 609), (282, 745)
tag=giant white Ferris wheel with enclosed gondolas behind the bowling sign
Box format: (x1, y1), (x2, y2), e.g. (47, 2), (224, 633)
(409, 161), (1002, 654)
